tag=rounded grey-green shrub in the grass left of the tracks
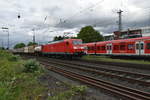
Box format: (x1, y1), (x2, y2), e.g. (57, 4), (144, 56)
(24, 59), (40, 72)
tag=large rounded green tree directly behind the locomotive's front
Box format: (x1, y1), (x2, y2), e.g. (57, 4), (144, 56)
(77, 26), (103, 43)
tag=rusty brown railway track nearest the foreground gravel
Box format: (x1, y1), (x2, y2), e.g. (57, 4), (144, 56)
(41, 61), (150, 100)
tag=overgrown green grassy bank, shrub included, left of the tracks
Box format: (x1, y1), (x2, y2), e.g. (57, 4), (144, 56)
(0, 50), (86, 100)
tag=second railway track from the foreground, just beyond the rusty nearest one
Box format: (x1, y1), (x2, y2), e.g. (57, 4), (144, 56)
(40, 59), (150, 87)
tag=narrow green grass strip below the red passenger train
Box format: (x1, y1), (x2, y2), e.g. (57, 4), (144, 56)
(82, 55), (150, 64)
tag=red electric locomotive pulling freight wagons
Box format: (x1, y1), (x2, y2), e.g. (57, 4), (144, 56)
(42, 39), (85, 56)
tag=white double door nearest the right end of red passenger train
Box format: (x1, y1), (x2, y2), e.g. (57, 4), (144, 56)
(135, 41), (144, 55)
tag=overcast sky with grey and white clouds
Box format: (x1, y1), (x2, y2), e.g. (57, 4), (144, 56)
(0, 0), (150, 46)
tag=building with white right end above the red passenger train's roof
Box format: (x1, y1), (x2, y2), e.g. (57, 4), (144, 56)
(114, 27), (150, 40)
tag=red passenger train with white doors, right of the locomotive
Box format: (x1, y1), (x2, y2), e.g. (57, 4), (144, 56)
(84, 37), (150, 56)
